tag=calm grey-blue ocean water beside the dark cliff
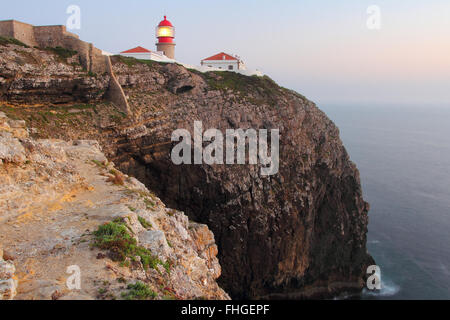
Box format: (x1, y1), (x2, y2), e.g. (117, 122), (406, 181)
(320, 105), (450, 299)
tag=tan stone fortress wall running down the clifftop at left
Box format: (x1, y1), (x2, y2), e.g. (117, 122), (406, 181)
(0, 20), (129, 113)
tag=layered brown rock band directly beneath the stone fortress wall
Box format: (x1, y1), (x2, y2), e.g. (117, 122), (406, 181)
(0, 45), (110, 105)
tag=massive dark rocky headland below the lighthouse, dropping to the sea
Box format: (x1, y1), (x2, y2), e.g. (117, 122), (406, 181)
(0, 43), (371, 298)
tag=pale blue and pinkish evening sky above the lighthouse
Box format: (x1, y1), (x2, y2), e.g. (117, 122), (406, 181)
(0, 0), (450, 107)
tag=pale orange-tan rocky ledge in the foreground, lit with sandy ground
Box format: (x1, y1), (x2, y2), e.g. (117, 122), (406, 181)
(0, 112), (229, 299)
